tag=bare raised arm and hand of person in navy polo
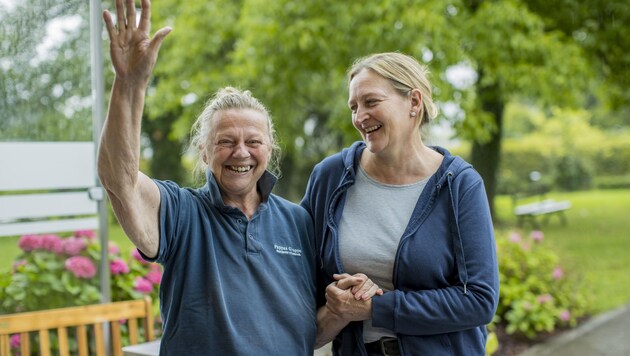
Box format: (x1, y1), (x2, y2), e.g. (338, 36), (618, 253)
(98, 0), (170, 257)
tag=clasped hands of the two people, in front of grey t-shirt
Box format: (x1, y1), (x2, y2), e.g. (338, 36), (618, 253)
(326, 273), (383, 322)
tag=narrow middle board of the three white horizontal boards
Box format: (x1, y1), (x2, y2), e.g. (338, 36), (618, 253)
(0, 191), (97, 223)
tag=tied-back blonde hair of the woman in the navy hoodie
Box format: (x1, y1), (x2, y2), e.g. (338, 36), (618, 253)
(348, 52), (438, 127)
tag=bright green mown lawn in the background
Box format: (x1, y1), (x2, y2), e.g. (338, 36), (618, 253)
(0, 189), (630, 313)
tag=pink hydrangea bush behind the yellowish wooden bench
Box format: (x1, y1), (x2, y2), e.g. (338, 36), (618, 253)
(0, 231), (162, 314)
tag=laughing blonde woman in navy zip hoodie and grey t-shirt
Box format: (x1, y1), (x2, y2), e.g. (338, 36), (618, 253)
(302, 53), (499, 356)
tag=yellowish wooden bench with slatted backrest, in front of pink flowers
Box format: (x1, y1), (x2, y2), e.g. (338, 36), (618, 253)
(0, 297), (155, 356)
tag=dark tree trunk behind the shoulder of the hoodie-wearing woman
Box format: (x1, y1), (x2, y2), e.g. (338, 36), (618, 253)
(471, 85), (505, 221)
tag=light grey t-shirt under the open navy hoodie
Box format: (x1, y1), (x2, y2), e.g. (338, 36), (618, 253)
(339, 167), (428, 342)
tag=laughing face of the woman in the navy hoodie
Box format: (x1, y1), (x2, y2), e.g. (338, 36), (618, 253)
(348, 69), (418, 153)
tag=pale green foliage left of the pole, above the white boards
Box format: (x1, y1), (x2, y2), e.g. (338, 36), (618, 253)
(0, 0), (92, 141)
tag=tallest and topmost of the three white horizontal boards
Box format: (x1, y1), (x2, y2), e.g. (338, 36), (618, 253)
(0, 142), (96, 191)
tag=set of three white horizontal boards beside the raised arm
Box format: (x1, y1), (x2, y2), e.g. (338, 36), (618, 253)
(0, 142), (102, 236)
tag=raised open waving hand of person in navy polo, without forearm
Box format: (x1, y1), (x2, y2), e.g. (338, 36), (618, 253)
(103, 0), (171, 84)
